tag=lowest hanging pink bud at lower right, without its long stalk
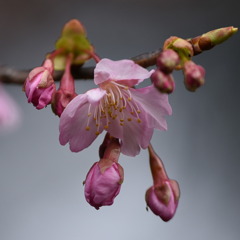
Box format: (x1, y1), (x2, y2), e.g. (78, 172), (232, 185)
(145, 180), (179, 222)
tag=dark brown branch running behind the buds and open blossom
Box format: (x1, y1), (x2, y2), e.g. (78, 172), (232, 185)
(0, 49), (161, 85)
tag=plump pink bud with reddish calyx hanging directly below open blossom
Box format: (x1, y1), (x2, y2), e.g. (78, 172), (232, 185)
(84, 138), (124, 209)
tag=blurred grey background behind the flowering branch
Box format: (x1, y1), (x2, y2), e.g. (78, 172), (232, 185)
(0, 0), (240, 240)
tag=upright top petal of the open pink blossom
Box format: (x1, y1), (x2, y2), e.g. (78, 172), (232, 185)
(94, 58), (152, 86)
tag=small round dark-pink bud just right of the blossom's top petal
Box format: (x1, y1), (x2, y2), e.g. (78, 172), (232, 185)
(151, 69), (175, 94)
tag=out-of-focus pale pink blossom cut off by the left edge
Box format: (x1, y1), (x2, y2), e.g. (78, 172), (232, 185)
(0, 83), (21, 132)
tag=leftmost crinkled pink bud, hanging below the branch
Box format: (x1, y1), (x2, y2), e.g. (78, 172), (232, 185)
(24, 59), (56, 109)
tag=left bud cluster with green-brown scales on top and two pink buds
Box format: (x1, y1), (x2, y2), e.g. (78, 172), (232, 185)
(23, 19), (95, 117)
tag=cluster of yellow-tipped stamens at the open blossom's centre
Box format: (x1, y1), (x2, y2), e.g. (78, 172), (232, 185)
(86, 81), (141, 135)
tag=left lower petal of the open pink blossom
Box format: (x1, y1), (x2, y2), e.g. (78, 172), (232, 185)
(59, 89), (104, 152)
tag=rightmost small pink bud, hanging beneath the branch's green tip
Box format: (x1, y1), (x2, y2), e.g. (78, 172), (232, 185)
(183, 61), (205, 92)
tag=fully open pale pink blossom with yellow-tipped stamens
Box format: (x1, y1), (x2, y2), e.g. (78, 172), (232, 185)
(59, 59), (172, 156)
